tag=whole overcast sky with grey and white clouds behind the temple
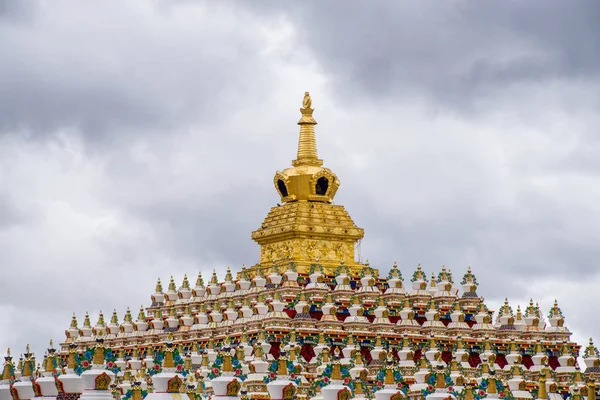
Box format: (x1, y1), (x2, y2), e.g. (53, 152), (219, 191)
(0, 0), (600, 357)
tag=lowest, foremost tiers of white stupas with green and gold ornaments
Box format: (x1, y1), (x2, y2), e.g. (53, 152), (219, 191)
(0, 329), (599, 400)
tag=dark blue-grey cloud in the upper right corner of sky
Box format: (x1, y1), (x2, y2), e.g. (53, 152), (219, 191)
(241, 1), (600, 112)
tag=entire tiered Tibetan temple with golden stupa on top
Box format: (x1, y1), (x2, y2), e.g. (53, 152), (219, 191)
(0, 93), (600, 400)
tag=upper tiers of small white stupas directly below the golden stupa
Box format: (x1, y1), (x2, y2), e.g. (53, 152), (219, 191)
(63, 265), (579, 350)
